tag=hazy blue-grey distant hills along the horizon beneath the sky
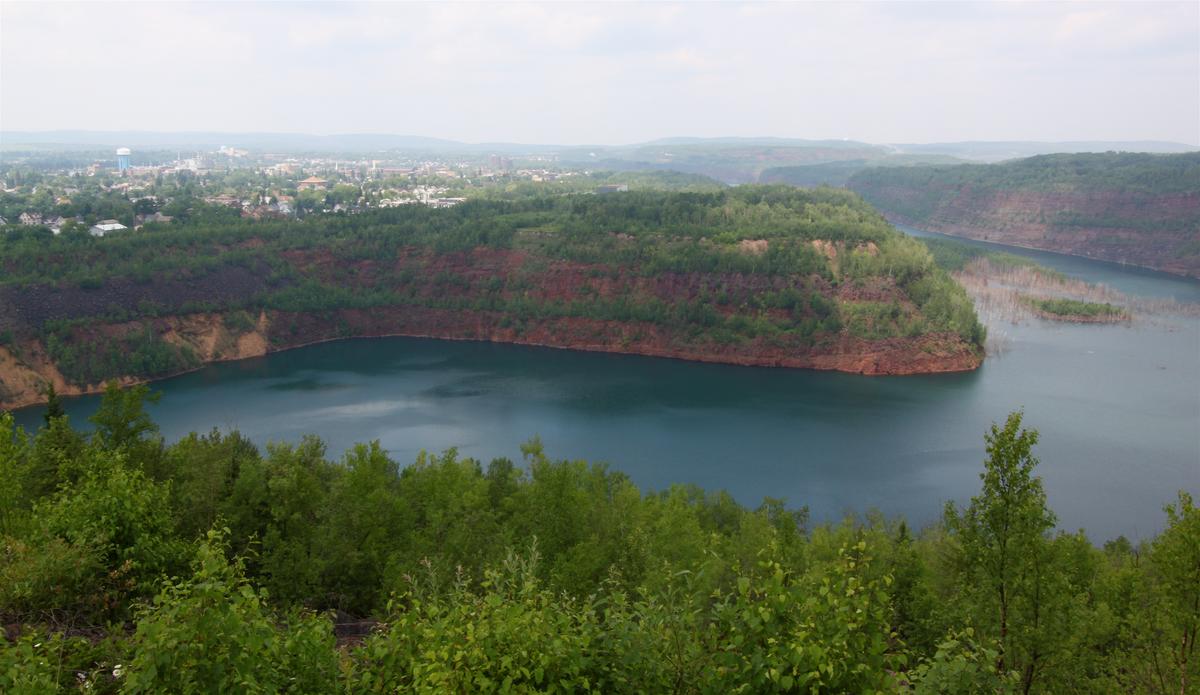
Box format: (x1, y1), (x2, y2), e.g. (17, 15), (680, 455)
(0, 131), (1200, 187)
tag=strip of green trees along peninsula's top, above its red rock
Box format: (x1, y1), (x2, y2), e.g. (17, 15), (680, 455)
(0, 186), (895, 286)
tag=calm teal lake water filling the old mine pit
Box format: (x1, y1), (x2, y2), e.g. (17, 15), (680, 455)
(17, 231), (1200, 541)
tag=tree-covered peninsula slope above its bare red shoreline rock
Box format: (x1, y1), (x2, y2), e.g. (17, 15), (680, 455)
(0, 186), (984, 384)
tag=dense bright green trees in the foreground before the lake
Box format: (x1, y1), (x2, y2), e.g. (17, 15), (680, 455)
(0, 385), (1200, 694)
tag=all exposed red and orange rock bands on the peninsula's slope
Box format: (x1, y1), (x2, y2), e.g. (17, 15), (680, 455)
(0, 248), (983, 409)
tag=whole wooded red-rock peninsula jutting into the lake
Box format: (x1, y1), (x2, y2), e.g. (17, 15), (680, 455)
(0, 186), (984, 408)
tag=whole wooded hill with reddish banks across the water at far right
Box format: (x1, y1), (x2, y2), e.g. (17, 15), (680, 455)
(847, 152), (1200, 277)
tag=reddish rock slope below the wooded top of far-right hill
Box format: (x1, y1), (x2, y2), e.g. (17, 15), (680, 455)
(859, 186), (1200, 277)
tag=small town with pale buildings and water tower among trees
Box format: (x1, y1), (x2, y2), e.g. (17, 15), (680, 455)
(0, 146), (600, 236)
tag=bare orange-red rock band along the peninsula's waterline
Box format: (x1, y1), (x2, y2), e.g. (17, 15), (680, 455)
(0, 306), (983, 409)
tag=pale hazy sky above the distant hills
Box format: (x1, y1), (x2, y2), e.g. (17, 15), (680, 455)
(0, 0), (1200, 144)
